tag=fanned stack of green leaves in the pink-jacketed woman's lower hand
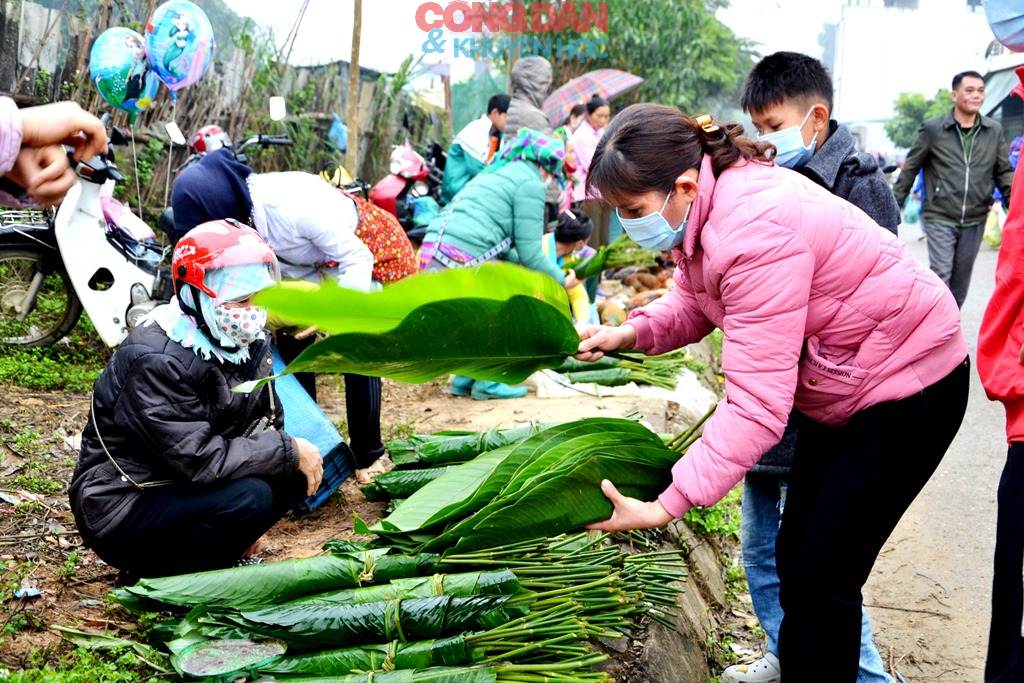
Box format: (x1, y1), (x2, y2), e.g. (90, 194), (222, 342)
(369, 418), (679, 552)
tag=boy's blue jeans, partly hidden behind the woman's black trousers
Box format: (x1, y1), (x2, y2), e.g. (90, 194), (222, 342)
(739, 473), (893, 683)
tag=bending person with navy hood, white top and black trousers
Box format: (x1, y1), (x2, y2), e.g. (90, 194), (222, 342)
(171, 147), (417, 469)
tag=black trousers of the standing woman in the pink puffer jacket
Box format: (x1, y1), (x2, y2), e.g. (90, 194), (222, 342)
(776, 358), (966, 683)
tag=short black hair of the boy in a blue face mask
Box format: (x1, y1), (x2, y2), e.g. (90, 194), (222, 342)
(739, 52), (833, 115)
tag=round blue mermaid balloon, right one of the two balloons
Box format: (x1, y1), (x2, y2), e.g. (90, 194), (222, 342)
(145, 0), (214, 99)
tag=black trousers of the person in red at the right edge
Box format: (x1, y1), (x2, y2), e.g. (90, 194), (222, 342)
(985, 442), (1024, 683)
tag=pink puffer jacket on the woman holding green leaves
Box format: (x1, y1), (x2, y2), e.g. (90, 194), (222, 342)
(629, 157), (968, 517)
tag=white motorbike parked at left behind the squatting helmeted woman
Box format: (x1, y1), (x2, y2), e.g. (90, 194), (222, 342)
(0, 118), (292, 347)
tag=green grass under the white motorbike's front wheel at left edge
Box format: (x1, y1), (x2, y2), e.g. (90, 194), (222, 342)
(0, 315), (113, 393)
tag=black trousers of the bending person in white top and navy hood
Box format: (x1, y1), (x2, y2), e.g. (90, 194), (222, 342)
(276, 331), (384, 469)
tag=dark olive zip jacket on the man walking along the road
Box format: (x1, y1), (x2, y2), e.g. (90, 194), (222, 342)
(893, 109), (1014, 226)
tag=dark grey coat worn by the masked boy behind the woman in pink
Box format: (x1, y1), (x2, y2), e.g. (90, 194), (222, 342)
(751, 121), (900, 477)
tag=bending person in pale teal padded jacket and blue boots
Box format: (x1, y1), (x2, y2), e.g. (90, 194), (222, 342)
(420, 128), (579, 399)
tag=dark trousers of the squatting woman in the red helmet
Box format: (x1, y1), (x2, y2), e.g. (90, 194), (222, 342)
(89, 472), (306, 578)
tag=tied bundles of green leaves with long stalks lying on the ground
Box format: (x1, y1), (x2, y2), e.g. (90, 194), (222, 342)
(103, 533), (684, 683)
